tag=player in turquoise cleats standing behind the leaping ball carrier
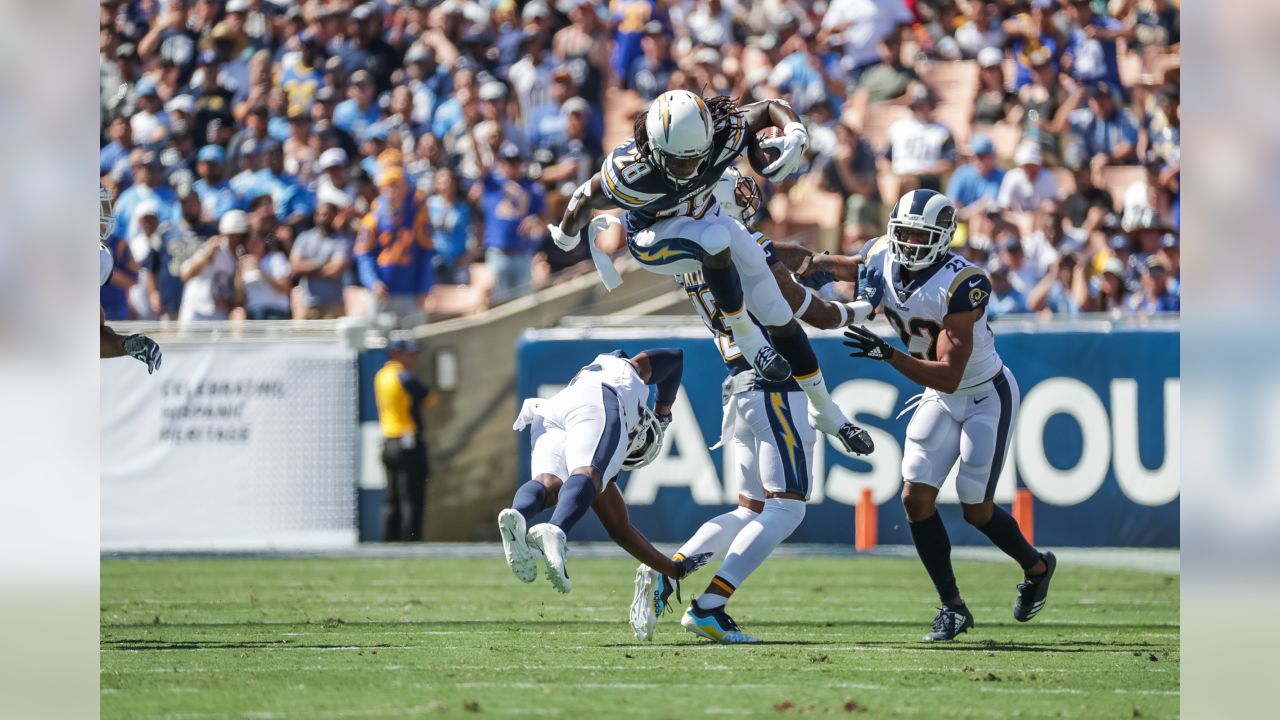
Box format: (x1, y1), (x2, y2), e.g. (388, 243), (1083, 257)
(630, 167), (872, 643)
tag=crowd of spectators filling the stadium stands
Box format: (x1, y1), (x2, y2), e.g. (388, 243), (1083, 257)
(100, 0), (1180, 322)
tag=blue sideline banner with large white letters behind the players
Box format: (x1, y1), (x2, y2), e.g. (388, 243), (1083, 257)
(512, 325), (1180, 547)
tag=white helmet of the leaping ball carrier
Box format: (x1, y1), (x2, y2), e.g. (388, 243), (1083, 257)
(644, 90), (716, 186)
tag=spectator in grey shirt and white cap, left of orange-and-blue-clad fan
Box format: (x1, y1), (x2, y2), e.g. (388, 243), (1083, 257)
(289, 197), (352, 320)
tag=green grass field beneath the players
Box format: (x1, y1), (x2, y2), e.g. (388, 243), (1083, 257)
(101, 557), (1179, 720)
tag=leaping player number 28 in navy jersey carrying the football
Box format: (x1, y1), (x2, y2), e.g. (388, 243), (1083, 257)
(549, 90), (863, 452)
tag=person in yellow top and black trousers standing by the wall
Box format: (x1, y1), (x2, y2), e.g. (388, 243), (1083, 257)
(374, 332), (435, 542)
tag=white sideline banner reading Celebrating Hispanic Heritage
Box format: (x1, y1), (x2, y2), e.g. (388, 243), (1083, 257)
(100, 342), (357, 551)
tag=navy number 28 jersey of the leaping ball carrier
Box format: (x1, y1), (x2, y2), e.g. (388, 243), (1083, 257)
(600, 113), (749, 232)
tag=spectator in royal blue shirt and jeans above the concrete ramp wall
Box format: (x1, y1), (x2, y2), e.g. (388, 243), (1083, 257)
(471, 145), (547, 302)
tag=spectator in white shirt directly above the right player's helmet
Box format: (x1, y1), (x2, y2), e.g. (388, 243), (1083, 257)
(884, 86), (956, 193)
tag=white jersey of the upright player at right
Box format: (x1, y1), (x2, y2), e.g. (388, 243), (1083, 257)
(860, 237), (1004, 391)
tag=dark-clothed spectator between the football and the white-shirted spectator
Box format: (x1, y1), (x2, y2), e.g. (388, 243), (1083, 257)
(822, 123), (884, 243)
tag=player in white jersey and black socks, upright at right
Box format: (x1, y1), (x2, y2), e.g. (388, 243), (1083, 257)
(845, 190), (1057, 641)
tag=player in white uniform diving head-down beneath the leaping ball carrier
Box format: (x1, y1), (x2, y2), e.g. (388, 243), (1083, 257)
(498, 348), (710, 592)
